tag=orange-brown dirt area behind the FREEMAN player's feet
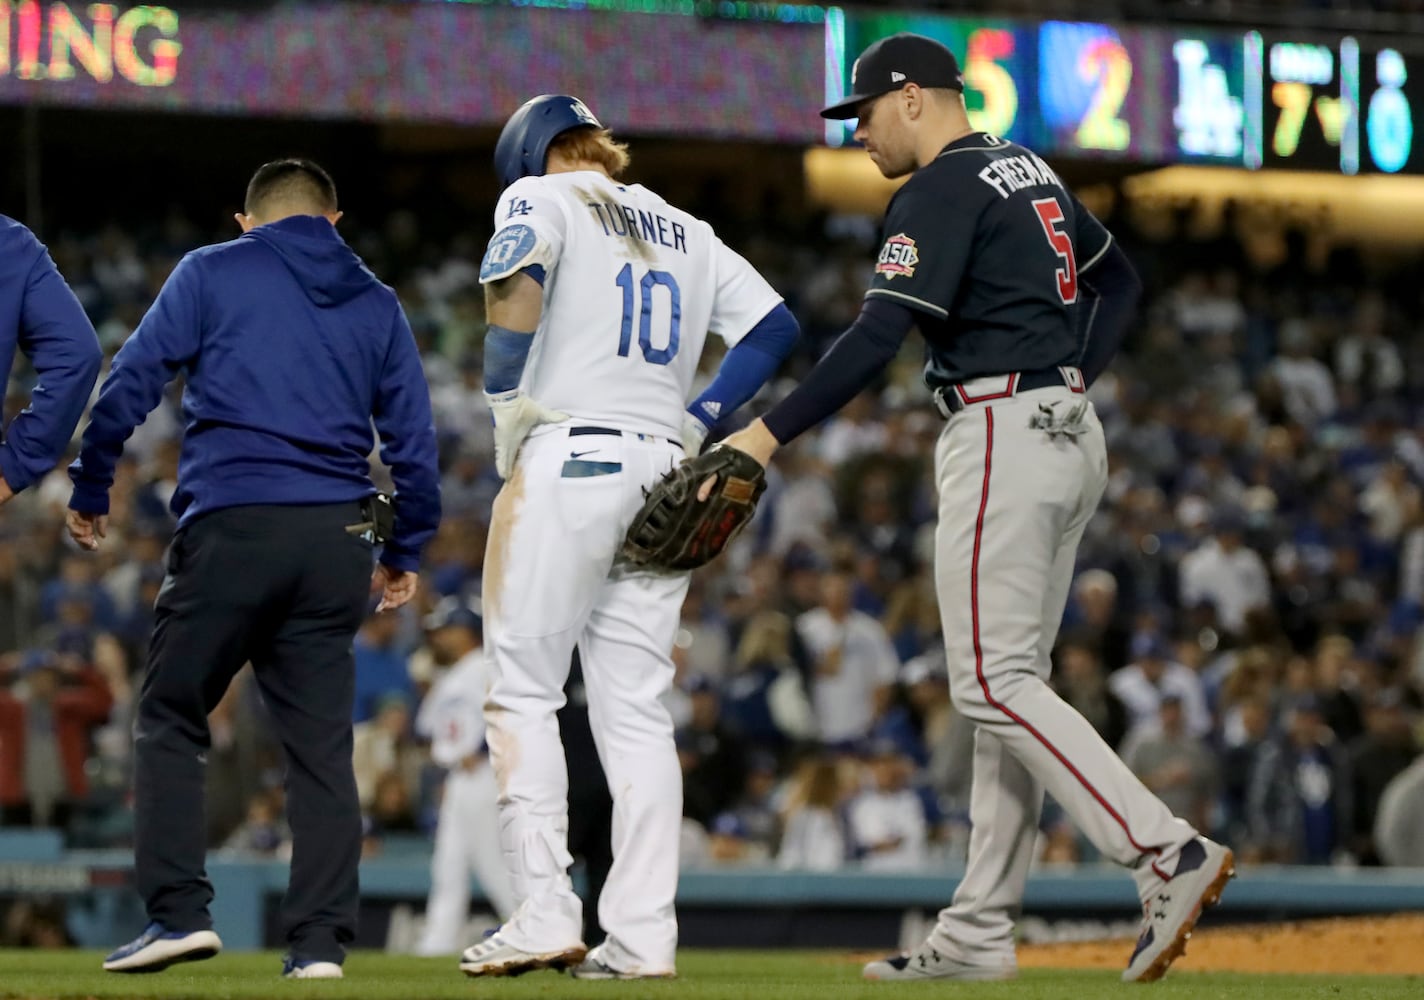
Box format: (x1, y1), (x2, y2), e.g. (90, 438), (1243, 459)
(1018, 913), (1424, 976)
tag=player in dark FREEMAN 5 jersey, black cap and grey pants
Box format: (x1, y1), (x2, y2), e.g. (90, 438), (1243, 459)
(726, 34), (1233, 980)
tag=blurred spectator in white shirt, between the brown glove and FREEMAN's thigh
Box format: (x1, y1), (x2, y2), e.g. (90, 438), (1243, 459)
(796, 568), (900, 745)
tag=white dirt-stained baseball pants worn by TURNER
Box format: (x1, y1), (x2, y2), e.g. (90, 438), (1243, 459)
(484, 425), (688, 973)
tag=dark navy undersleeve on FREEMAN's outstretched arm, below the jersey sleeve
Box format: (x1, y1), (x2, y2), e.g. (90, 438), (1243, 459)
(762, 298), (914, 444)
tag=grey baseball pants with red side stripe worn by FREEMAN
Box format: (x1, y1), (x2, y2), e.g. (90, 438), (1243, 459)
(931, 379), (1196, 964)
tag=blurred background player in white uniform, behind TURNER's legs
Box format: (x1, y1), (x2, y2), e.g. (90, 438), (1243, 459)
(416, 597), (514, 954)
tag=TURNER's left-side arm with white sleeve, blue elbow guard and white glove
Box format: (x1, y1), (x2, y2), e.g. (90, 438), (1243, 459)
(480, 178), (568, 479)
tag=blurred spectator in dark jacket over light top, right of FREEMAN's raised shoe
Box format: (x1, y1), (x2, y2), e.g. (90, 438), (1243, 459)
(1246, 695), (1353, 865)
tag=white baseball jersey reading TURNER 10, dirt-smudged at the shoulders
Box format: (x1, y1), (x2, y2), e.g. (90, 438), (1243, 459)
(480, 171), (782, 439)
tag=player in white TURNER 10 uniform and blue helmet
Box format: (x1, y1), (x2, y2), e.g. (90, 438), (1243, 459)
(460, 95), (797, 979)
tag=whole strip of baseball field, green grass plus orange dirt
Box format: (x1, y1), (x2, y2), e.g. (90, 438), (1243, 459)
(0, 916), (1424, 1000)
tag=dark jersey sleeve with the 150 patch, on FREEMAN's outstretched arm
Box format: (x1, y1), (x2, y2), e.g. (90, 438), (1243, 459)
(866, 184), (980, 319)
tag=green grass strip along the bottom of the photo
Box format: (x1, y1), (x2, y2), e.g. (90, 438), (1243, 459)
(0, 950), (1424, 1000)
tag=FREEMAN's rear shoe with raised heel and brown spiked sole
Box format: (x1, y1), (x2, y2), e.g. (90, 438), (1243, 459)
(1122, 836), (1236, 983)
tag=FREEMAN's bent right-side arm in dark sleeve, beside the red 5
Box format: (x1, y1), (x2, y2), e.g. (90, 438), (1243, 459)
(1069, 195), (1142, 386)
